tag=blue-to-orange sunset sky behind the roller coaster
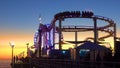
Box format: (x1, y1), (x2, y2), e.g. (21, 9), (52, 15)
(0, 0), (120, 59)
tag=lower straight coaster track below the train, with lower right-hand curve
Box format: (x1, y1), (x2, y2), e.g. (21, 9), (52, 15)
(62, 26), (114, 40)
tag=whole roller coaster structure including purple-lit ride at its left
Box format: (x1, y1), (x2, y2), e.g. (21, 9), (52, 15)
(34, 11), (116, 57)
